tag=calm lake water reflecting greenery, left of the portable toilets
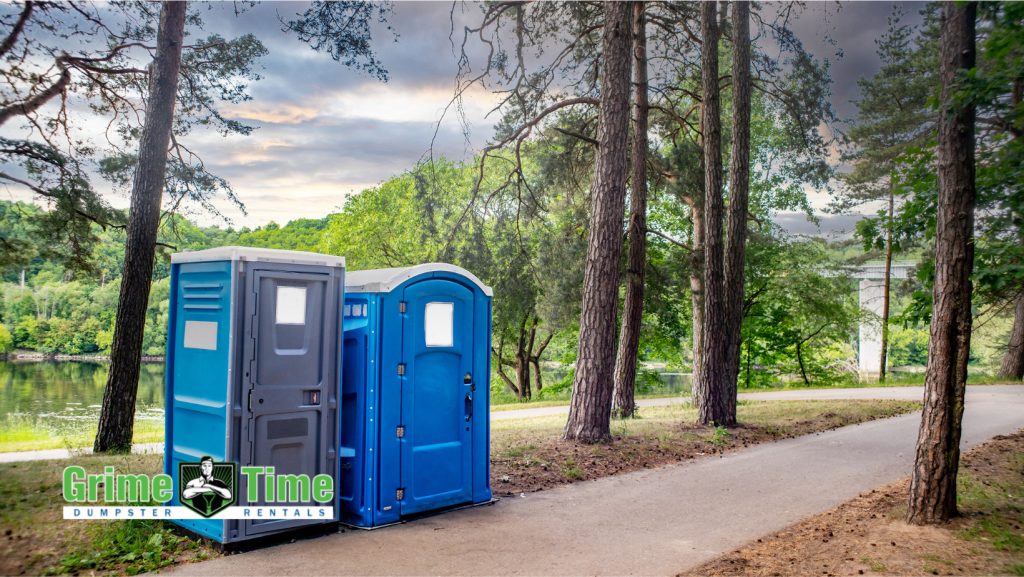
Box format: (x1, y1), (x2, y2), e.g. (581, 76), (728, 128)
(0, 361), (164, 441)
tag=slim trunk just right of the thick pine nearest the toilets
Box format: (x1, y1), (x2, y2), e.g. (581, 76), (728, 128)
(613, 2), (647, 417)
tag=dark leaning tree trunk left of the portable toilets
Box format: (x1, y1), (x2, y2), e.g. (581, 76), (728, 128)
(93, 2), (186, 453)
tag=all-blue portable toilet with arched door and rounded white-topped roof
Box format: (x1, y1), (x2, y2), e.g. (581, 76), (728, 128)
(338, 263), (493, 528)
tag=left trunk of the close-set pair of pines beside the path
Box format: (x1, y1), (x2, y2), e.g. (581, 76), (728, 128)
(693, 2), (735, 426)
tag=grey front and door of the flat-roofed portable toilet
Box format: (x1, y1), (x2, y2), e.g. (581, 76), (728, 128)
(242, 259), (341, 537)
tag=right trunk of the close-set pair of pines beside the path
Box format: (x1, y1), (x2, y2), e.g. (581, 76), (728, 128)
(725, 2), (751, 421)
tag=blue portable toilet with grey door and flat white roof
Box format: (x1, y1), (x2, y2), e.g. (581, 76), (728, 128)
(164, 247), (345, 544)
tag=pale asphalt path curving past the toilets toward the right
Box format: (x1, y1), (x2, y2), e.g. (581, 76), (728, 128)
(165, 385), (1024, 576)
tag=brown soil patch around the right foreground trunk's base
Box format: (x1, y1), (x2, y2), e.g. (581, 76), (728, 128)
(685, 429), (1024, 576)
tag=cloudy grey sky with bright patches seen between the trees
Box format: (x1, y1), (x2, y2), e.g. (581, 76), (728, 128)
(0, 2), (921, 234)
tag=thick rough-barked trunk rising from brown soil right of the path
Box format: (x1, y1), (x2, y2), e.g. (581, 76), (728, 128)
(907, 2), (977, 525)
